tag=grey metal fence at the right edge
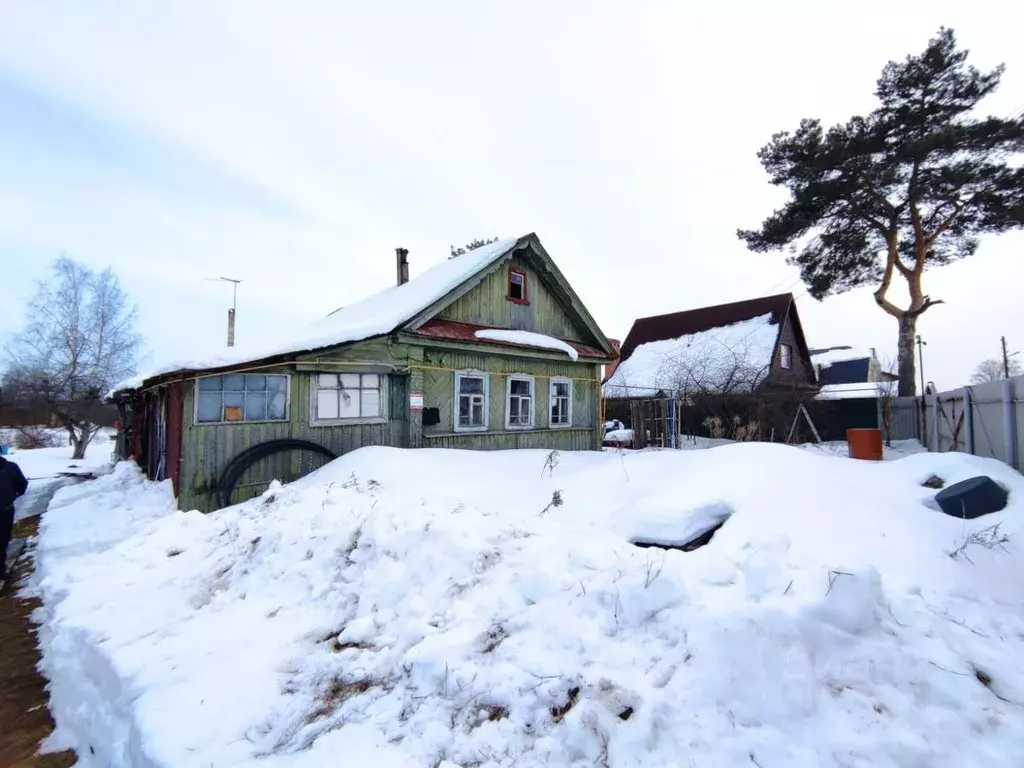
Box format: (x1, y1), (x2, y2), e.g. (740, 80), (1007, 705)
(890, 376), (1024, 470)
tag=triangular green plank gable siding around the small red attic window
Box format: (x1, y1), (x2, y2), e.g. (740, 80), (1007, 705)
(438, 257), (591, 342)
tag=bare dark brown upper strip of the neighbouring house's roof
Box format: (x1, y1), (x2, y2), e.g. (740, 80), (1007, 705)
(620, 293), (807, 364)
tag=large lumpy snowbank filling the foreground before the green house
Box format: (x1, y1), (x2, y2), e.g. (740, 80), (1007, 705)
(39, 443), (1024, 768)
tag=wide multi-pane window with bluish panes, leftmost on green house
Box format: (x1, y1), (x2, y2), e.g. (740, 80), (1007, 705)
(196, 374), (289, 424)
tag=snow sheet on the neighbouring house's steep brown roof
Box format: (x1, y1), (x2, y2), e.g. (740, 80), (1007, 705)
(604, 313), (778, 397)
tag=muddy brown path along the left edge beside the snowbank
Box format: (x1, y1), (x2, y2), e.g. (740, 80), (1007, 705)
(0, 483), (77, 768)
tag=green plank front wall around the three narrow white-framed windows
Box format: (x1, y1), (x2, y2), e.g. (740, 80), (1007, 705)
(422, 348), (601, 451)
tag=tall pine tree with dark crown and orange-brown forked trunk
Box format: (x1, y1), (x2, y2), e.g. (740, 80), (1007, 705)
(737, 29), (1024, 395)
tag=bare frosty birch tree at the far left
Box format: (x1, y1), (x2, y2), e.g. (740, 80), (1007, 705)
(4, 256), (140, 459)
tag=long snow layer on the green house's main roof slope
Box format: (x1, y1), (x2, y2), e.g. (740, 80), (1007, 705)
(113, 238), (522, 392)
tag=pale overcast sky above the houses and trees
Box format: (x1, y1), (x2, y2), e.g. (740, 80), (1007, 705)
(0, 0), (1024, 388)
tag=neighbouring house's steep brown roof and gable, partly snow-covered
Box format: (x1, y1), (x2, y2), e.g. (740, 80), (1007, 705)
(603, 293), (818, 400)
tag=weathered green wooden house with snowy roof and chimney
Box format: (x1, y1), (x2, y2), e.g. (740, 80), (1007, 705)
(112, 234), (615, 511)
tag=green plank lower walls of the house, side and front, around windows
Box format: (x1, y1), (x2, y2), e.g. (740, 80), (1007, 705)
(178, 327), (601, 511)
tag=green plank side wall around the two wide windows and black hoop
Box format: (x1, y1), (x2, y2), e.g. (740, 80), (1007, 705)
(178, 364), (410, 512)
